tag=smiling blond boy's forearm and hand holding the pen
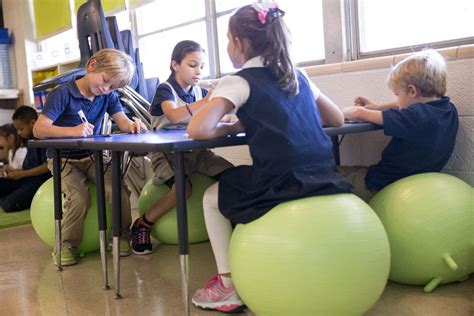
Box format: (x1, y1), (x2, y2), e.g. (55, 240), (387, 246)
(33, 114), (94, 139)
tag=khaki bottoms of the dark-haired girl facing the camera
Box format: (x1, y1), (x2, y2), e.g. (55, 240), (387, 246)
(150, 150), (233, 185)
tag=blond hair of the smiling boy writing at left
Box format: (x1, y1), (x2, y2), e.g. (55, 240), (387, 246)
(86, 48), (135, 88)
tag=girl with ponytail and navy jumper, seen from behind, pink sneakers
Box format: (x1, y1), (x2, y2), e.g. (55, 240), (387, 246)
(188, 3), (351, 312)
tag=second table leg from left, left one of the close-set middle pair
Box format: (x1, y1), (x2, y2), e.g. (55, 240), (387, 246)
(94, 150), (110, 290)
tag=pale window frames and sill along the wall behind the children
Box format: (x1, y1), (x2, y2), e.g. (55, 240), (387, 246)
(130, 0), (474, 78)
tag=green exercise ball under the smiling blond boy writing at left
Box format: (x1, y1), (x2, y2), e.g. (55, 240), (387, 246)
(30, 178), (112, 254)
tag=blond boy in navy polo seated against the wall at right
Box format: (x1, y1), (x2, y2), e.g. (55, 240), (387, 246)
(338, 50), (459, 202)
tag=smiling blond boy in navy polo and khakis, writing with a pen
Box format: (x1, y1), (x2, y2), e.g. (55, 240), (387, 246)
(34, 49), (146, 266)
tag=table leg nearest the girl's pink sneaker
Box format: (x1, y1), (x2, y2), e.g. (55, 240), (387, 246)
(175, 152), (189, 316)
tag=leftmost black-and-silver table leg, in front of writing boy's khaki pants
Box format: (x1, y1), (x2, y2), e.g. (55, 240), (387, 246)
(53, 148), (63, 271)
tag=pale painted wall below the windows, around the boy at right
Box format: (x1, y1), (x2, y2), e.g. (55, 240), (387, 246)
(216, 50), (474, 185)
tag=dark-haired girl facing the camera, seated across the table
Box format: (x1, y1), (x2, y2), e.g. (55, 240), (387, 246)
(132, 41), (232, 254)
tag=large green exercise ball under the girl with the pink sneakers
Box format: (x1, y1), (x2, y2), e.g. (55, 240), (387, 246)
(229, 194), (390, 316)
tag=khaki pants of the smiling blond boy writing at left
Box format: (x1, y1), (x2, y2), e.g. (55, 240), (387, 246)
(48, 157), (132, 247)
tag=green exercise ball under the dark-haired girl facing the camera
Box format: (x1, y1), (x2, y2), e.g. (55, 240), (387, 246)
(138, 173), (215, 245)
